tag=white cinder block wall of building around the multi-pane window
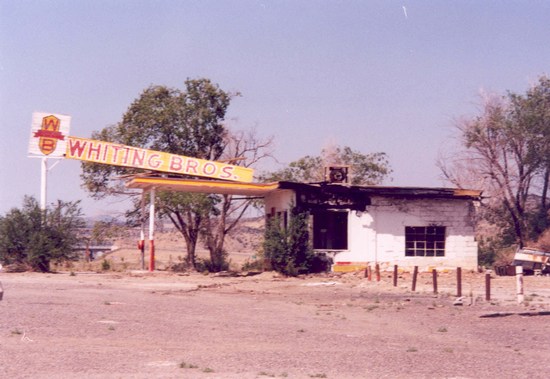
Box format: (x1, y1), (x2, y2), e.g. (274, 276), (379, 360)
(342, 197), (477, 270)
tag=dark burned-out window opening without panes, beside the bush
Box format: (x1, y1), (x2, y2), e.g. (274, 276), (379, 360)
(313, 210), (348, 250)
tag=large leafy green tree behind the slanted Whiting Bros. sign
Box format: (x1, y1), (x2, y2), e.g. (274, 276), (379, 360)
(81, 78), (234, 269)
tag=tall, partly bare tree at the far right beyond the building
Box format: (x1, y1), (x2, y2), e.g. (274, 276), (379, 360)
(439, 76), (550, 251)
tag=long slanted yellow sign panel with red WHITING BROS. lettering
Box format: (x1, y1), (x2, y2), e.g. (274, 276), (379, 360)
(65, 136), (254, 183)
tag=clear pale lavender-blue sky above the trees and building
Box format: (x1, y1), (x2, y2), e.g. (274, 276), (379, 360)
(0, 0), (550, 216)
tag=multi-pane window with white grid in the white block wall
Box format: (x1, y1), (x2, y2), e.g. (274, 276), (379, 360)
(405, 226), (445, 257)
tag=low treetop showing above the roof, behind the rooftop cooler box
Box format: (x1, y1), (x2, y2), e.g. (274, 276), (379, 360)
(262, 146), (391, 185)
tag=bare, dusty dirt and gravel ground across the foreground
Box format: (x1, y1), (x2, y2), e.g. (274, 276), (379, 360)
(0, 271), (550, 378)
